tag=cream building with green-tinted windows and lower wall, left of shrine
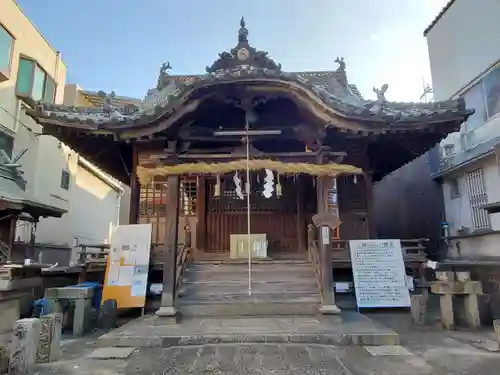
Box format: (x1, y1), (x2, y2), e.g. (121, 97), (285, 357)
(0, 0), (126, 264)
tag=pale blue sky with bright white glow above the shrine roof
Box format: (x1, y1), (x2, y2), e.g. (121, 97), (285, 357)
(17, 0), (447, 101)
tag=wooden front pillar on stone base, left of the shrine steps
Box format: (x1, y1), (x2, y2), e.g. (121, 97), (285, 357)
(156, 176), (180, 316)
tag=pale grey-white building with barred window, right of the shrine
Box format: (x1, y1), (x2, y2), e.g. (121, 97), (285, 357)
(424, 0), (500, 258)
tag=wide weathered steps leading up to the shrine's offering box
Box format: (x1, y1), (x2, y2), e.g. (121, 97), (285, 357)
(176, 260), (320, 316)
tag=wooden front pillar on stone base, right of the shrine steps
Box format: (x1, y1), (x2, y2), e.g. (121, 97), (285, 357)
(316, 154), (340, 314)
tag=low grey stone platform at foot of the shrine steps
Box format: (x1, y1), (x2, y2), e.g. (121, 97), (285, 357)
(98, 312), (399, 348)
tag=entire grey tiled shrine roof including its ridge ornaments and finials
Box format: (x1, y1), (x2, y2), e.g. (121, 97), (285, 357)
(29, 15), (473, 138)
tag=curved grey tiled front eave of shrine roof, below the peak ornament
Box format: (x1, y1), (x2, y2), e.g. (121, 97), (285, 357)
(32, 66), (472, 134)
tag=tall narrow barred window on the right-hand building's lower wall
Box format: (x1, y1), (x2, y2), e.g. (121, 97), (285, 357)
(467, 168), (491, 231)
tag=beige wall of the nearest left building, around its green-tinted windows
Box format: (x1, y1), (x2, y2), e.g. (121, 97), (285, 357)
(0, 0), (72, 214)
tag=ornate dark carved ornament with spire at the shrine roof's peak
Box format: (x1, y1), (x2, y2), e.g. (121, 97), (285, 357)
(205, 17), (281, 73)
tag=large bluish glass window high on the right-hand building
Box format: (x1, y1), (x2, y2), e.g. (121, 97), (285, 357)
(463, 63), (500, 131)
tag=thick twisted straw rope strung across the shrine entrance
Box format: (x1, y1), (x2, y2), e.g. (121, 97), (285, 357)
(137, 159), (363, 184)
